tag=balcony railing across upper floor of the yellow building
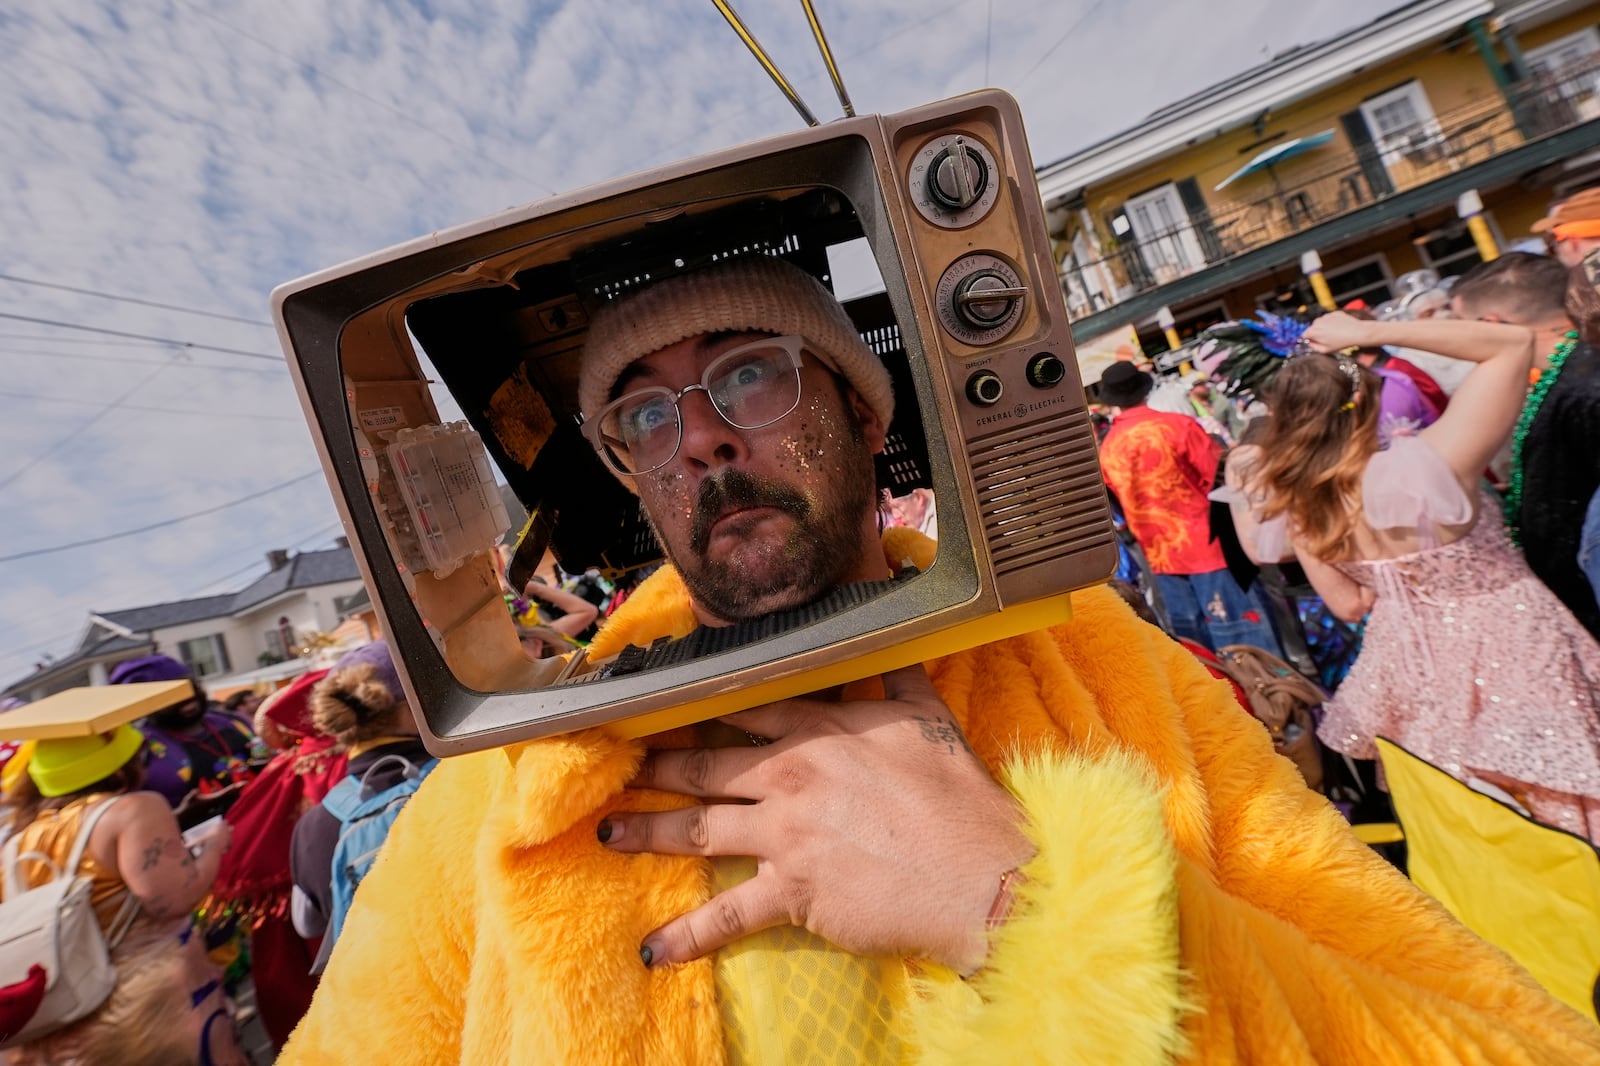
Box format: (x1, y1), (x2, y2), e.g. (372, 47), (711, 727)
(1061, 56), (1600, 317)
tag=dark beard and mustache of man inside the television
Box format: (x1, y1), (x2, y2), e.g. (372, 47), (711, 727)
(656, 450), (877, 623)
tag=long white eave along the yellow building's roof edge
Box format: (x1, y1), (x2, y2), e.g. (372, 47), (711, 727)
(1038, 0), (1494, 206)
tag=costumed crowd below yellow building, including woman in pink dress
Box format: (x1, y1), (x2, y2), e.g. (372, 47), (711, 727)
(1098, 192), (1600, 842)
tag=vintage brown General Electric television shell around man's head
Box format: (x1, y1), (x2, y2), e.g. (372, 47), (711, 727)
(272, 90), (1117, 755)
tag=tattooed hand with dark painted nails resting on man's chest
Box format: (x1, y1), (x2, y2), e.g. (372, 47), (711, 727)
(600, 666), (1032, 972)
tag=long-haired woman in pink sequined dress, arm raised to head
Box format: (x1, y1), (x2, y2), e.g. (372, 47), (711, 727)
(1246, 314), (1600, 840)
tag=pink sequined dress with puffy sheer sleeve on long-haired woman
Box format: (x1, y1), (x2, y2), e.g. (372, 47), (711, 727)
(1318, 437), (1600, 842)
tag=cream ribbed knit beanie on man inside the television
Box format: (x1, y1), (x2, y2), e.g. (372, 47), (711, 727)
(578, 254), (894, 426)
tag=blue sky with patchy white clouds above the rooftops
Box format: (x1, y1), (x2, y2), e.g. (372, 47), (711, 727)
(0, 0), (1397, 685)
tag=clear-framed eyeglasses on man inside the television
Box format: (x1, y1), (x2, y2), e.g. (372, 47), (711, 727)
(584, 336), (805, 477)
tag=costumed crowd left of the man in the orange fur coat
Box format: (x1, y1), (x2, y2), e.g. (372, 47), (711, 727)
(0, 630), (434, 1066)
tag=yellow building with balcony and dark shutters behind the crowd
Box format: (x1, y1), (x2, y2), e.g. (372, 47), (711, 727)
(1038, 0), (1600, 369)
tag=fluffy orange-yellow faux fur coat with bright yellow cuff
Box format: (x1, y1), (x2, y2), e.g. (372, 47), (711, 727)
(280, 534), (1600, 1066)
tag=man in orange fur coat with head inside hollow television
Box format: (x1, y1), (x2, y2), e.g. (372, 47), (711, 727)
(280, 258), (1600, 1066)
